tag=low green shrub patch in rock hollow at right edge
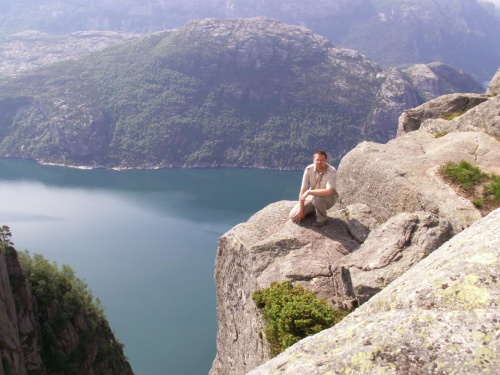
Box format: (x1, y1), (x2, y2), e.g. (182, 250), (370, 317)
(439, 161), (500, 214)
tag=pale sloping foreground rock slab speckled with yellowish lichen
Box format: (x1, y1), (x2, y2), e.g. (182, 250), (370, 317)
(249, 209), (500, 375)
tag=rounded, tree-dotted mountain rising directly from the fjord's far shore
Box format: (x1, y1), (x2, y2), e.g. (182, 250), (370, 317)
(0, 18), (484, 168)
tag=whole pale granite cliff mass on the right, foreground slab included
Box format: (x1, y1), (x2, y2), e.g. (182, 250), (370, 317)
(211, 68), (500, 375)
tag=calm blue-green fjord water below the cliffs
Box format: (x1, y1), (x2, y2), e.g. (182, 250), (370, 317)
(0, 159), (301, 375)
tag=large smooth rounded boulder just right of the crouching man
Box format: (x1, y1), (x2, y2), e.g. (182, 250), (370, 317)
(337, 129), (500, 233)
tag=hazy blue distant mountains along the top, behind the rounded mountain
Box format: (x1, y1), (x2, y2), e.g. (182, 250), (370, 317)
(0, 0), (500, 81)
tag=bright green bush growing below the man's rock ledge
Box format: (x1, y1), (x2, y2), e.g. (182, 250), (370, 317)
(252, 281), (345, 355)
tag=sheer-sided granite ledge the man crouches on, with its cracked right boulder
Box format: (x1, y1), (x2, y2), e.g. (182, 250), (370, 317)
(210, 201), (451, 375)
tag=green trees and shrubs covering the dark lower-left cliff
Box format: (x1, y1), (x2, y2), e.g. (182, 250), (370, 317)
(17, 251), (128, 375)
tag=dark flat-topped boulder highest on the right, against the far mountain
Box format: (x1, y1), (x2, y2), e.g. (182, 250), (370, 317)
(397, 94), (488, 136)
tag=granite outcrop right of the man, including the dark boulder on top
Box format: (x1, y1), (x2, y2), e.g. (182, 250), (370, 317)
(338, 88), (500, 233)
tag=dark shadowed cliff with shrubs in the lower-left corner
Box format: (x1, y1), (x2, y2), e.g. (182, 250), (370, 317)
(0, 247), (133, 375)
